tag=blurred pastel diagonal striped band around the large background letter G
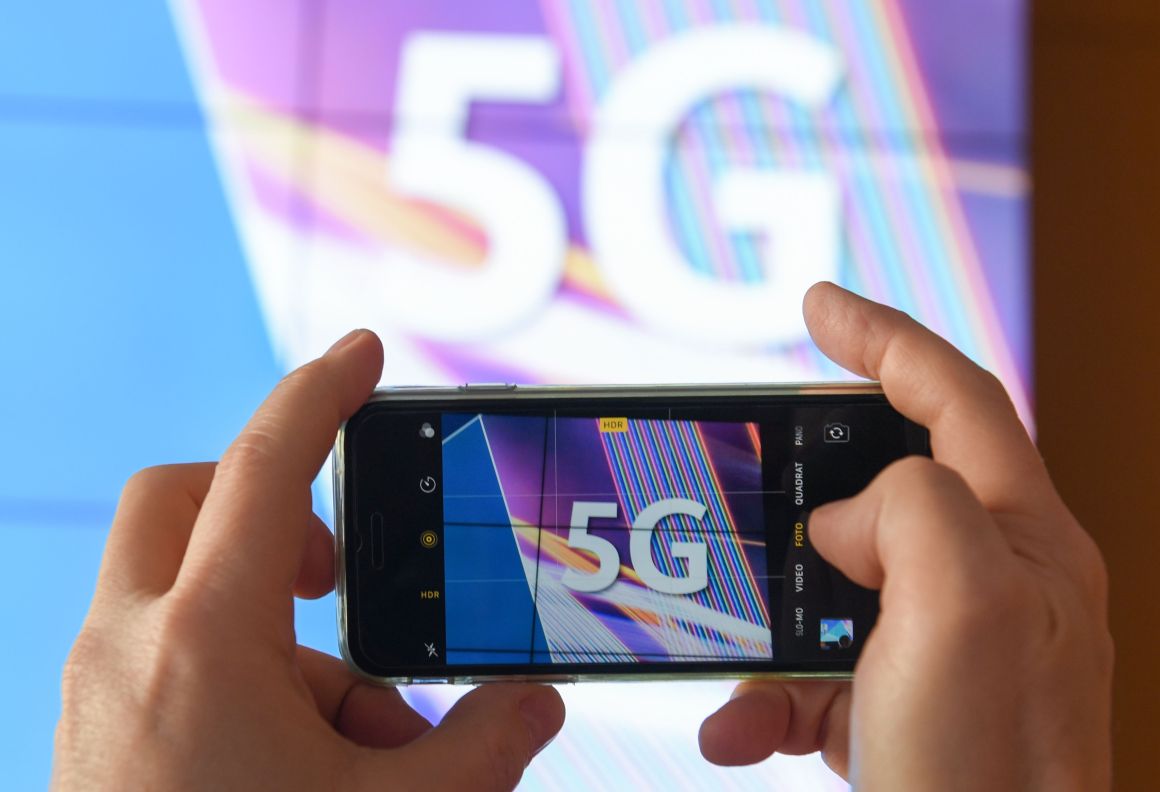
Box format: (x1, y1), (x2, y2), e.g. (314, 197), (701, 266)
(541, 0), (1030, 420)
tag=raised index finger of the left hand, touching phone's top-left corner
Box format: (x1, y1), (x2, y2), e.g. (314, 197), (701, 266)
(175, 330), (383, 618)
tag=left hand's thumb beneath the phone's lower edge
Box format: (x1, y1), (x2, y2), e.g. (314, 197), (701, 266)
(387, 684), (564, 792)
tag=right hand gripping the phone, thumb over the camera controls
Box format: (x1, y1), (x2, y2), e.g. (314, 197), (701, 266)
(701, 284), (1112, 792)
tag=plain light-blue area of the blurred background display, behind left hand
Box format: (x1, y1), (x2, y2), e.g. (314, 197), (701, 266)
(0, 0), (335, 790)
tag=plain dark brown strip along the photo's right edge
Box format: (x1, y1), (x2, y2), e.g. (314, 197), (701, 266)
(1031, 0), (1160, 790)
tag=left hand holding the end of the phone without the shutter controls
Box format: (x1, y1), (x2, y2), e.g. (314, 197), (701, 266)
(53, 332), (564, 790)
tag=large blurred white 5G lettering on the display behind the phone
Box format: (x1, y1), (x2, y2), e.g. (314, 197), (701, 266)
(384, 24), (841, 347)
